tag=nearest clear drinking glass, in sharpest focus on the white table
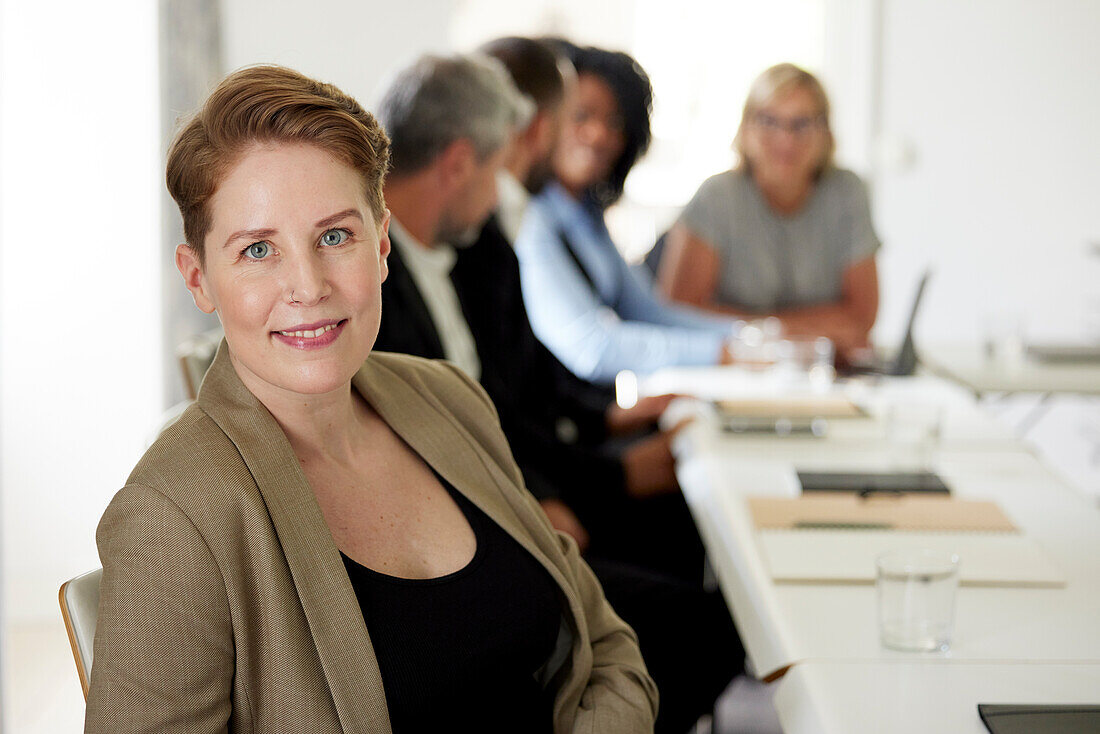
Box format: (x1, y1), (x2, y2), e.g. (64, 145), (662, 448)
(876, 549), (959, 651)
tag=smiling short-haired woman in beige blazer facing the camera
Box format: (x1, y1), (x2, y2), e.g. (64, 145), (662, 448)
(86, 67), (656, 734)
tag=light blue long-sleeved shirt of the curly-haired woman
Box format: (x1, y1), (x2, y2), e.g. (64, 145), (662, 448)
(516, 184), (739, 384)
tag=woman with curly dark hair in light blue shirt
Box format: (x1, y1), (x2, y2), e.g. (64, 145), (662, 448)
(516, 42), (739, 383)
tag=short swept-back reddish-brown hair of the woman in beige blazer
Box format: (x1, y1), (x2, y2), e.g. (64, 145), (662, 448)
(165, 65), (389, 262)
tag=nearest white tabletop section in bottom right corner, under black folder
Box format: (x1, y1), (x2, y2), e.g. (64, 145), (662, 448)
(773, 660), (1100, 734)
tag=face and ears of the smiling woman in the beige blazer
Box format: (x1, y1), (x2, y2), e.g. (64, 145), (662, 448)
(176, 143), (389, 402)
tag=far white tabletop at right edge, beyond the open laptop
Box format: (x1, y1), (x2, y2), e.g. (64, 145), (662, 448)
(919, 344), (1100, 395)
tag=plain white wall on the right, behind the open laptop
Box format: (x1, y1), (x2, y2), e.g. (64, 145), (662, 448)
(875, 0), (1100, 341)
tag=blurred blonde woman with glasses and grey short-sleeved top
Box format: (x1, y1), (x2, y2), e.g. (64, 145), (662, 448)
(658, 64), (880, 351)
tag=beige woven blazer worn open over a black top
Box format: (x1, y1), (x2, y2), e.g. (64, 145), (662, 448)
(85, 342), (657, 734)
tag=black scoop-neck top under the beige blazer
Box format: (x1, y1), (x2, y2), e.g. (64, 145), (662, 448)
(341, 474), (561, 734)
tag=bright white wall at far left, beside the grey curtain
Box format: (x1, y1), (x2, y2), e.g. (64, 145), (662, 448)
(0, 0), (166, 622)
